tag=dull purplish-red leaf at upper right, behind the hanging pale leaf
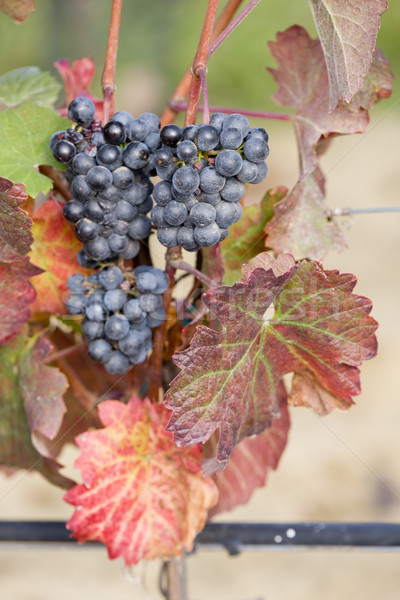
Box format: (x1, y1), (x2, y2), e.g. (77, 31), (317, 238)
(268, 25), (390, 176)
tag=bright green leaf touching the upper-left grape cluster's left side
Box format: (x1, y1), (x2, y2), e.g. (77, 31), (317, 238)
(0, 102), (69, 197)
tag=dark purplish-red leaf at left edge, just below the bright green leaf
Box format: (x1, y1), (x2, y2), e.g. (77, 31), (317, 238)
(0, 177), (33, 262)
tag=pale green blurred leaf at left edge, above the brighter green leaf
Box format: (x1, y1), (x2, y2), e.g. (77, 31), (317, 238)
(0, 67), (61, 110)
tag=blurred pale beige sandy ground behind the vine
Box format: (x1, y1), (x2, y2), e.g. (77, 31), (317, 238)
(0, 111), (400, 600)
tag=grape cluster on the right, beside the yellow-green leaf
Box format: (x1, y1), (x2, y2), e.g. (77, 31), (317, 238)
(151, 113), (269, 252)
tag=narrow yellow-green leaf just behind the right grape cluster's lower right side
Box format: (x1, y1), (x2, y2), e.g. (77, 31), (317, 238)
(221, 186), (288, 285)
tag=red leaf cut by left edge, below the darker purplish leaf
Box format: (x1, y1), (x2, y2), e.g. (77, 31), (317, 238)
(0, 258), (42, 344)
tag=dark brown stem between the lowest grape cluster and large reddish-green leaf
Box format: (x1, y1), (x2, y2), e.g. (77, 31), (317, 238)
(148, 246), (182, 402)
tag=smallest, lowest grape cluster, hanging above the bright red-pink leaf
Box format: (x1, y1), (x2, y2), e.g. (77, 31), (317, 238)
(66, 265), (168, 375)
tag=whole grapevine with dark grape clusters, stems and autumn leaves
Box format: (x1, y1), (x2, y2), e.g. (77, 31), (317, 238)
(0, 0), (392, 598)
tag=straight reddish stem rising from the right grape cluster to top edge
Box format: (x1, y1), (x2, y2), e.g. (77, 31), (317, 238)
(185, 0), (219, 125)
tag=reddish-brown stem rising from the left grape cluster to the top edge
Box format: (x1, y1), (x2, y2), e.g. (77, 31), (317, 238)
(101, 0), (123, 123)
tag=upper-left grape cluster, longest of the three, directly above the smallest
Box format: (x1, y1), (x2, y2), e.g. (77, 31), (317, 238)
(50, 97), (161, 267)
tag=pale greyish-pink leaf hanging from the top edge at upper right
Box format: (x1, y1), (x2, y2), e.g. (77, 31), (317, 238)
(309, 0), (388, 110)
